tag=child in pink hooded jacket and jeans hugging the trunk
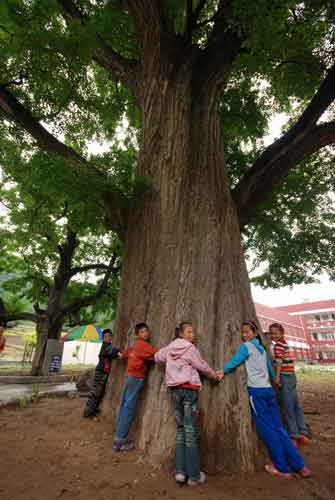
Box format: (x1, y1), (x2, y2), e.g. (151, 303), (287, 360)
(155, 322), (220, 486)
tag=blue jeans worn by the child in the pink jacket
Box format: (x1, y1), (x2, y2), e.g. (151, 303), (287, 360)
(170, 387), (200, 481)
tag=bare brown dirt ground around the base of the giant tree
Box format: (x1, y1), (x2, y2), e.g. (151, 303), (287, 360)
(0, 374), (335, 500)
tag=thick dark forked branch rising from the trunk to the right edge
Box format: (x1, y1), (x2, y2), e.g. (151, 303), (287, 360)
(233, 64), (335, 227)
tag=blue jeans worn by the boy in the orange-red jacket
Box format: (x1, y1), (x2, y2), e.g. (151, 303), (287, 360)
(114, 377), (144, 444)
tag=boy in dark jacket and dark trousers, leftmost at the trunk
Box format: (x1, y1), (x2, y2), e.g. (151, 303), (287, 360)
(84, 328), (120, 418)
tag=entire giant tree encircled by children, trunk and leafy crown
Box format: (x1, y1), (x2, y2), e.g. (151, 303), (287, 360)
(0, 0), (335, 470)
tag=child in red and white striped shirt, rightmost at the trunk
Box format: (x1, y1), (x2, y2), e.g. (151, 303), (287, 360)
(270, 323), (310, 446)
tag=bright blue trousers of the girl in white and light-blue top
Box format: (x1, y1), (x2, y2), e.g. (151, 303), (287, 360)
(248, 387), (304, 472)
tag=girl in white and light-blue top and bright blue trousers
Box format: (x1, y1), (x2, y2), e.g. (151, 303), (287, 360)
(223, 321), (311, 479)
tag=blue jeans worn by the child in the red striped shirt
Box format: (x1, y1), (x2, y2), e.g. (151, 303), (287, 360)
(280, 373), (308, 438)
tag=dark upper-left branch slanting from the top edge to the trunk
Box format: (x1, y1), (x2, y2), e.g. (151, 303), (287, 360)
(58, 0), (137, 94)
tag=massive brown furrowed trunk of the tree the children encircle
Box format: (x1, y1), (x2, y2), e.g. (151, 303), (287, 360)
(108, 68), (258, 471)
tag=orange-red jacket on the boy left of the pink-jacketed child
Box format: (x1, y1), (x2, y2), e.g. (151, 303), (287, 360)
(122, 339), (158, 378)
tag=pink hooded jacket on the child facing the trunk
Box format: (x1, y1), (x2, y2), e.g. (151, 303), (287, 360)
(155, 338), (215, 387)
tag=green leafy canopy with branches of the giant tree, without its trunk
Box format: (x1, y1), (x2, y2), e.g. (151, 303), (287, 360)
(0, 0), (335, 286)
